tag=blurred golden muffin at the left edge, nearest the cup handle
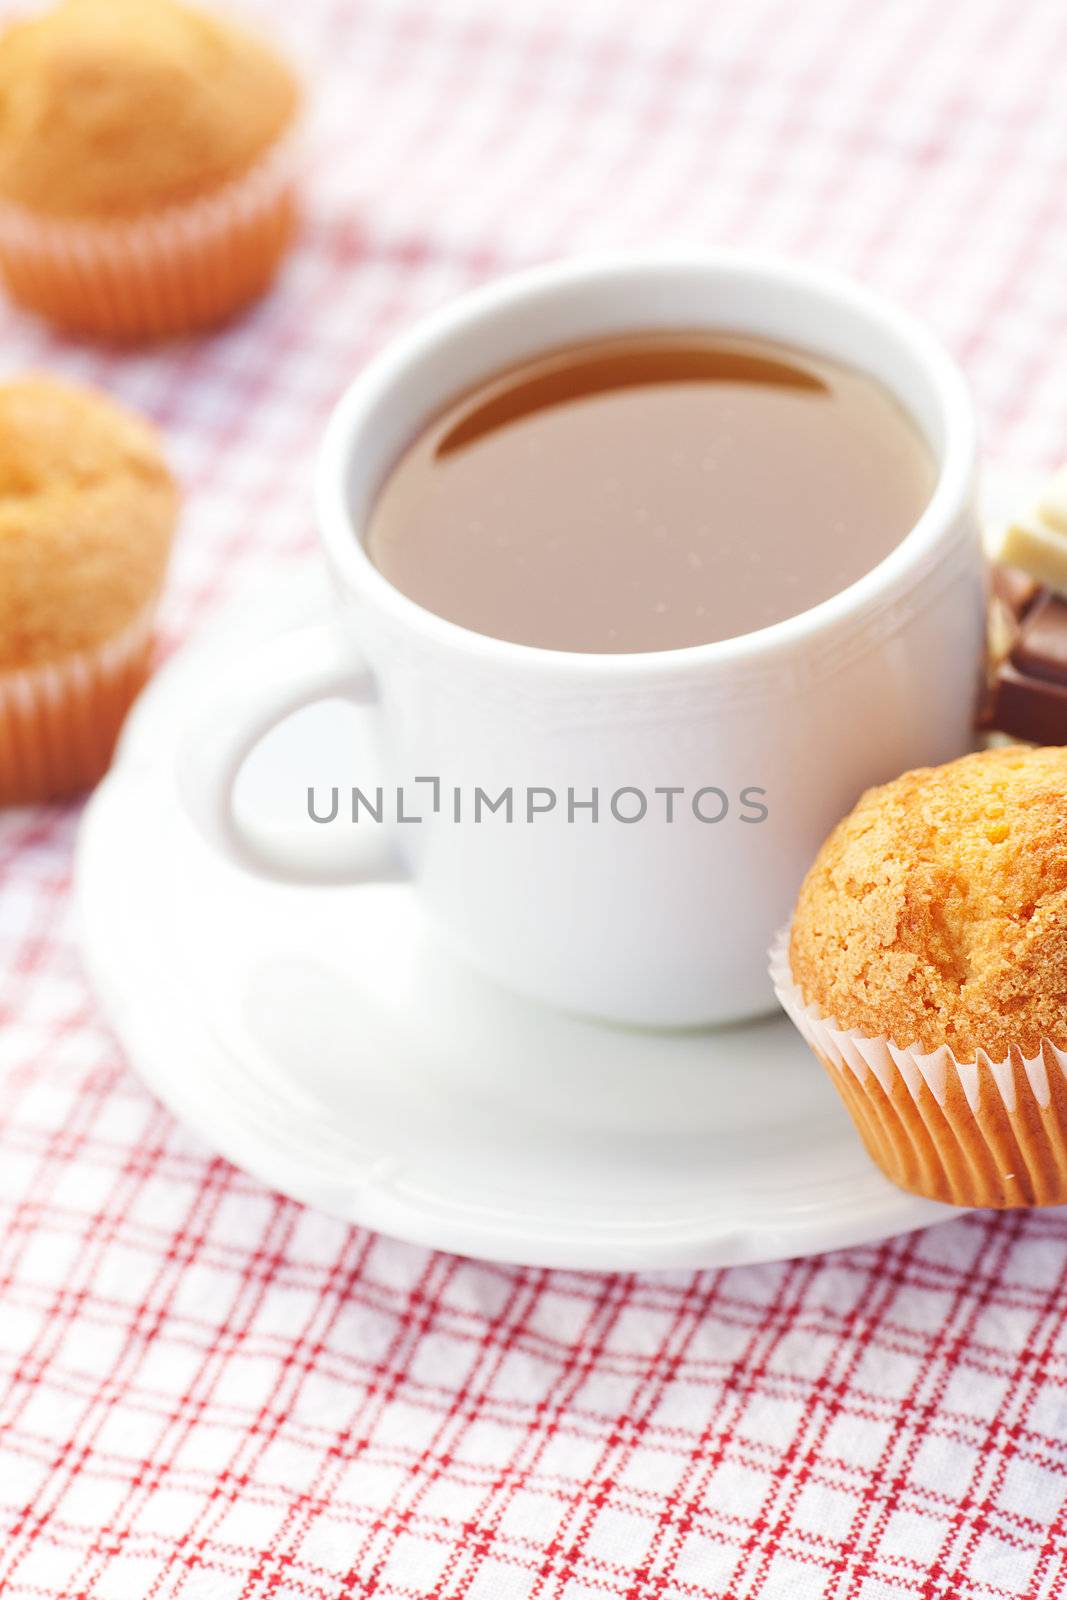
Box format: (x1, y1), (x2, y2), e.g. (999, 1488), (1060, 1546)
(0, 376), (178, 805)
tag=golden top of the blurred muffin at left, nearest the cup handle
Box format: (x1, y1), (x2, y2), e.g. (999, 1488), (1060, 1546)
(0, 376), (178, 670)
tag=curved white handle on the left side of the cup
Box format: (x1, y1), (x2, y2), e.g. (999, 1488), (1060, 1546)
(176, 622), (405, 883)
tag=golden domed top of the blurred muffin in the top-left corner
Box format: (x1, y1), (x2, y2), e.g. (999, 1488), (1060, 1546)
(0, 0), (298, 221)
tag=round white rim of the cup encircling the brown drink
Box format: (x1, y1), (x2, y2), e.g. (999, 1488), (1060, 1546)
(315, 251), (977, 680)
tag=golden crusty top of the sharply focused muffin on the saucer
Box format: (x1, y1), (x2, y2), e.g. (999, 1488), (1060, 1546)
(789, 746), (1067, 1061)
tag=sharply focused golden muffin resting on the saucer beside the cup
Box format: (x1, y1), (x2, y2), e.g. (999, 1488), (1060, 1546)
(771, 746), (1067, 1206)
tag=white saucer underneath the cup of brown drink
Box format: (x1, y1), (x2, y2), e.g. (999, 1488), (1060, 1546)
(77, 560), (1004, 1269)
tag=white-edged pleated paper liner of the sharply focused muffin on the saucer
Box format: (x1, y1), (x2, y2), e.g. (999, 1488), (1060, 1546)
(769, 928), (1067, 1206)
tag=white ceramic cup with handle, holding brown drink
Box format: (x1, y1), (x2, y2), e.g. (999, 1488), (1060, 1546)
(179, 254), (984, 1027)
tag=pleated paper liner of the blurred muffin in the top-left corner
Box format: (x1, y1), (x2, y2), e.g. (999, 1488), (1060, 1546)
(0, 133), (298, 341)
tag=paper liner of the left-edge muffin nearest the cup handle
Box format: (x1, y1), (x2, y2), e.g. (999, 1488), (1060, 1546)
(0, 605), (155, 805)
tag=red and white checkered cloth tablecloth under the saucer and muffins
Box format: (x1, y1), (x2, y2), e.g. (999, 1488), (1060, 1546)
(0, 0), (1067, 1600)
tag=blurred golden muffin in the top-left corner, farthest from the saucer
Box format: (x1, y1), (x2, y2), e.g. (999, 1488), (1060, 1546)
(0, 0), (298, 339)
